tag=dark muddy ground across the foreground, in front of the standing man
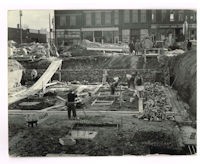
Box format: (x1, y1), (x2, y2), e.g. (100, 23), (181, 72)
(9, 112), (184, 156)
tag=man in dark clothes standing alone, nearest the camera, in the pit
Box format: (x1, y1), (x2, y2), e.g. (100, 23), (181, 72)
(66, 90), (78, 119)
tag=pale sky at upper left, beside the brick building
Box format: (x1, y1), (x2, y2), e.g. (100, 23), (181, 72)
(8, 10), (54, 30)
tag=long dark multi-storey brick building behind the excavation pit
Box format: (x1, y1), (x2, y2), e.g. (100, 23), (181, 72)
(55, 10), (196, 45)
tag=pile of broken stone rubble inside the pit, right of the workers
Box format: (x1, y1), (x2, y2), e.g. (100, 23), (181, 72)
(141, 82), (172, 121)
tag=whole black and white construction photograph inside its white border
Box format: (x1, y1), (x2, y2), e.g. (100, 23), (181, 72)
(7, 6), (197, 157)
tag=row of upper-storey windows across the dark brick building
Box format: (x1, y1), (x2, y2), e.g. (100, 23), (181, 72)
(60, 10), (196, 26)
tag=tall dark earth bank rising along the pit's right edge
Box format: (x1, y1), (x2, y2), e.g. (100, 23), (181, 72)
(170, 50), (197, 117)
